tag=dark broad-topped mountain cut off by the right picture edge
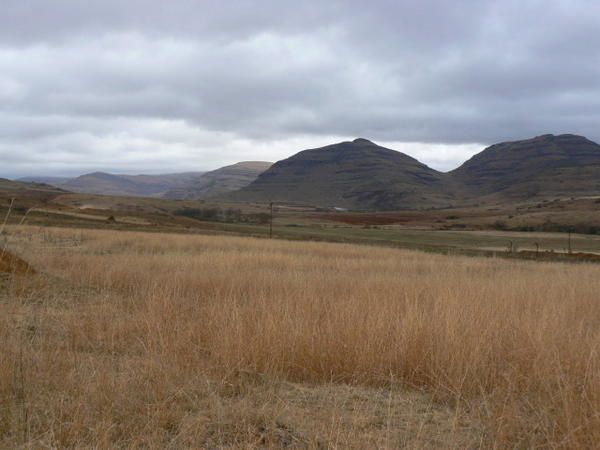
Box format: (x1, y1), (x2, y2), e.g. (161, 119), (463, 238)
(449, 134), (600, 200)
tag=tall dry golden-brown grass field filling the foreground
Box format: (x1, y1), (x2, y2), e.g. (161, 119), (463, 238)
(0, 227), (600, 449)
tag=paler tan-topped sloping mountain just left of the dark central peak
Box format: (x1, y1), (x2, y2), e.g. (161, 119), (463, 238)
(164, 161), (273, 200)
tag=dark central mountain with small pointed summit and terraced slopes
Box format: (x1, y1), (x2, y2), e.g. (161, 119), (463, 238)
(227, 139), (460, 209)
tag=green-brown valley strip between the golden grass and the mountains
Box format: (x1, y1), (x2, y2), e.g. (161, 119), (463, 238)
(0, 190), (600, 261)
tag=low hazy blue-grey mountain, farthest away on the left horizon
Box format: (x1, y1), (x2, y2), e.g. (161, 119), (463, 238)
(58, 172), (202, 197)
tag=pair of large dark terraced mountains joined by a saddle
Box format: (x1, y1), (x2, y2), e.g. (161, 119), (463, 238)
(228, 134), (600, 210)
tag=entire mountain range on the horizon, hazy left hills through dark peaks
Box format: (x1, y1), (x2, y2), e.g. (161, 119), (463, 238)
(15, 134), (600, 210)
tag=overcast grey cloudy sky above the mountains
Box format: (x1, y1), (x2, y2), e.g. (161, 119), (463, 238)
(0, 0), (600, 178)
